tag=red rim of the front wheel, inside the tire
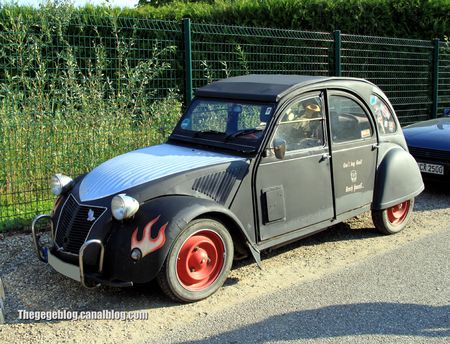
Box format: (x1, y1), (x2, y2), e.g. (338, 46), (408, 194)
(177, 229), (225, 290)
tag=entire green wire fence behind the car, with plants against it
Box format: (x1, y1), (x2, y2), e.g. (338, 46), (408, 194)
(0, 15), (450, 230)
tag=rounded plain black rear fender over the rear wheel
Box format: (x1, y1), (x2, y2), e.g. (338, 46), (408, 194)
(372, 148), (425, 210)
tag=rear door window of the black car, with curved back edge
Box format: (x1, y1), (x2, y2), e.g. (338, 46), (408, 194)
(330, 96), (373, 143)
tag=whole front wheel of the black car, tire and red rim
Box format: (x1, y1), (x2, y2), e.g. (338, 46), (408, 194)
(156, 219), (234, 302)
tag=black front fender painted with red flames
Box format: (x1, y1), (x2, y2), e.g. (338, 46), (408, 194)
(105, 196), (245, 283)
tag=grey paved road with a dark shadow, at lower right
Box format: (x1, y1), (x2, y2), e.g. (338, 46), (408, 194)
(152, 231), (450, 343)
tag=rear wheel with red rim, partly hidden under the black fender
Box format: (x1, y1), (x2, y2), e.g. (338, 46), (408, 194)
(372, 198), (414, 234)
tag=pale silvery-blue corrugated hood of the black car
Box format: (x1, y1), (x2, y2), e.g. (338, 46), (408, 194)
(79, 144), (245, 202)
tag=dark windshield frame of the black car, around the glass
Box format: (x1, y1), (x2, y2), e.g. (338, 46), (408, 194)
(169, 97), (278, 153)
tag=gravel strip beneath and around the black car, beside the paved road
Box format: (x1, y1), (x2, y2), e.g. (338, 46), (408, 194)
(0, 183), (450, 343)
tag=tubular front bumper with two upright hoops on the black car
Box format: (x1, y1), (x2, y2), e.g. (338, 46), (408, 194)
(31, 215), (133, 288)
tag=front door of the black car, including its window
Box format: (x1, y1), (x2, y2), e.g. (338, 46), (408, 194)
(255, 92), (333, 240)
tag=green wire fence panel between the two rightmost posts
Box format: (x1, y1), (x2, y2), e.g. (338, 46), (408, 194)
(341, 35), (433, 124)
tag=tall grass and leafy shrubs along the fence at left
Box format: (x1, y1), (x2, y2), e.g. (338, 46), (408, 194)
(0, 7), (181, 232)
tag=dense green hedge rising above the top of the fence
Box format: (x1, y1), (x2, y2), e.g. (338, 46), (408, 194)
(138, 0), (450, 39)
